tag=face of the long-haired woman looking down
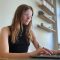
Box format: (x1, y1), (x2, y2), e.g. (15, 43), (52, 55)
(22, 9), (32, 25)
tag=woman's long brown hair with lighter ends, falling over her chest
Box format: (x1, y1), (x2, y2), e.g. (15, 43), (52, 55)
(11, 4), (33, 43)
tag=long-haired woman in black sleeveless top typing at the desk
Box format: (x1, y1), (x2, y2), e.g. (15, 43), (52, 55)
(0, 4), (52, 58)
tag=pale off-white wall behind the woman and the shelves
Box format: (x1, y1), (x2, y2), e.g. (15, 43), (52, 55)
(0, 0), (53, 51)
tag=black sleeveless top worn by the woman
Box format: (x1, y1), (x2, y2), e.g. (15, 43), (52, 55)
(8, 26), (30, 53)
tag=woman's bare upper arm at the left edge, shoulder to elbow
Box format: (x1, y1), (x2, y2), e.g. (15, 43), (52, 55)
(0, 27), (9, 53)
